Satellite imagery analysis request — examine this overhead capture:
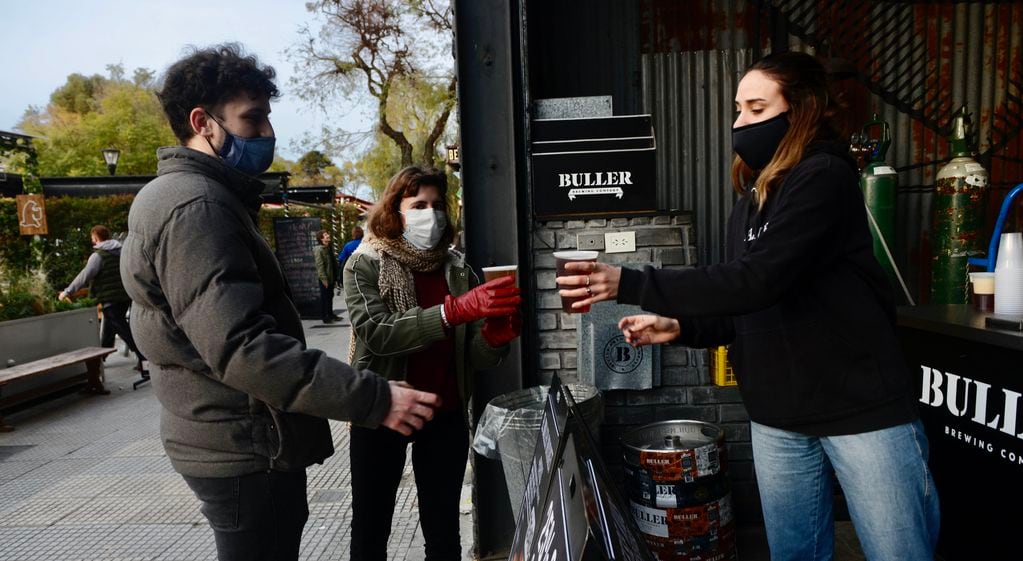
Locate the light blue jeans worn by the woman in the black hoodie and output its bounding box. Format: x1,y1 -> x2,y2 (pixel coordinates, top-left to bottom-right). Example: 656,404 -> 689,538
750,421 -> 940,561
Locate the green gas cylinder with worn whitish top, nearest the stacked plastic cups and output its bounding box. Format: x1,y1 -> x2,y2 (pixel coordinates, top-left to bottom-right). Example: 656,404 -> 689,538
931,105 -> 988,304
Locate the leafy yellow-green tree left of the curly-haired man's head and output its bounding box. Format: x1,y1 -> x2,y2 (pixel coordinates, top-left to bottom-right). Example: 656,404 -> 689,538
18,64 -> 177,176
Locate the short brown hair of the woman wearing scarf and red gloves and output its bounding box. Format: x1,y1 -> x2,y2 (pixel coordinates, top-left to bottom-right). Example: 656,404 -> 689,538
366,166 -> 454,248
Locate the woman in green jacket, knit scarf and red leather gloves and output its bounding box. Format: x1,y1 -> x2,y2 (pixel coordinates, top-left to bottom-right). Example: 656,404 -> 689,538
343,167 -> 522,561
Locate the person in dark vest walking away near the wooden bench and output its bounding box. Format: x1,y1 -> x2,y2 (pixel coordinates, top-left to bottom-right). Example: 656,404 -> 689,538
57,224 -> 149,379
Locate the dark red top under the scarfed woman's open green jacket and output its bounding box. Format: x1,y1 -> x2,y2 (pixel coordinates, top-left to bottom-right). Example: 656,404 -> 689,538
406,267 -> 461,411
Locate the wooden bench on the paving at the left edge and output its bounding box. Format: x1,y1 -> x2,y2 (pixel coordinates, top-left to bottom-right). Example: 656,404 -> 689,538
0,347 -> 117,432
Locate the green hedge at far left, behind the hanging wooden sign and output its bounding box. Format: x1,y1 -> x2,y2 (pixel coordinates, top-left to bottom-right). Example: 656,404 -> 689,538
0,196 -> 134,292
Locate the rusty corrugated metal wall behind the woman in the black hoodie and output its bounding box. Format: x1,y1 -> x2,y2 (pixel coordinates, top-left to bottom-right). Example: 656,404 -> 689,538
640,0 -> 1023,295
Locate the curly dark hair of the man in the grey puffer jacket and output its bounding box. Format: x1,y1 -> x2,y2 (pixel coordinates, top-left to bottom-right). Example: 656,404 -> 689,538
157,43 -> 280,144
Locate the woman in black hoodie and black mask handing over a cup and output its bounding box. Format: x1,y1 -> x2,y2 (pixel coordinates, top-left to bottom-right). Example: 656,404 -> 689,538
558,53 -> 939,561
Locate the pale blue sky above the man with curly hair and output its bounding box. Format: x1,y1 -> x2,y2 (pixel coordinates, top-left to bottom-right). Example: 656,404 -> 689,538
0,0 -> 371,160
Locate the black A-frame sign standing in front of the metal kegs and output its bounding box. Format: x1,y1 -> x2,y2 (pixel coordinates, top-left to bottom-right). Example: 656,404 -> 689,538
508,375 -> 654,561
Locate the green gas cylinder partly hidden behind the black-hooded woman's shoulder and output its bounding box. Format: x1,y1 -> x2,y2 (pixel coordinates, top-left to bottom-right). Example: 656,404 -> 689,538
858,114 -> 898,283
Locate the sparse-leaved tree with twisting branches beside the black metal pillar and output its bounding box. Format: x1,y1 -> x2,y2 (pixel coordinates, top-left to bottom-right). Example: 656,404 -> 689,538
291,0 -> 457,168
